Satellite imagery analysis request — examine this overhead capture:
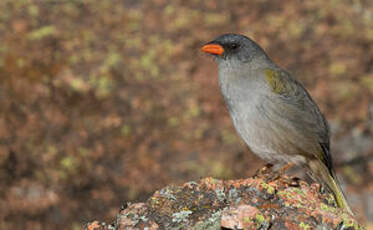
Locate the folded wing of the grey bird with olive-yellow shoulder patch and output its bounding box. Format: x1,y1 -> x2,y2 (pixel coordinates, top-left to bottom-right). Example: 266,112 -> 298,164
265,69 -> 332,164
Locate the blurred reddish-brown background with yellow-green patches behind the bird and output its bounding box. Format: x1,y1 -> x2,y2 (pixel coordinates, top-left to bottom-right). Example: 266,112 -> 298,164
0,0 -> 373,230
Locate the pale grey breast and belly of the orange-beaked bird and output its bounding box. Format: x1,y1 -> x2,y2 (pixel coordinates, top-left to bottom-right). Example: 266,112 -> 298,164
217,71 -> 312,164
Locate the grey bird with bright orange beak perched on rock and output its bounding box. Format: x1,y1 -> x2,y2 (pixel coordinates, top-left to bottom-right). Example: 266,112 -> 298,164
201,33 -> 354,215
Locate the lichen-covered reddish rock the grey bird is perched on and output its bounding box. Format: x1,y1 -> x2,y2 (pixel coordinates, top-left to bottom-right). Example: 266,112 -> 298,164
86,169 -> 364,230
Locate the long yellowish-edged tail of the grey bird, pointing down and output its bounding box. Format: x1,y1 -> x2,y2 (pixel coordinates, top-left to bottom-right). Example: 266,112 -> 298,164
310,160 -> 354,215
